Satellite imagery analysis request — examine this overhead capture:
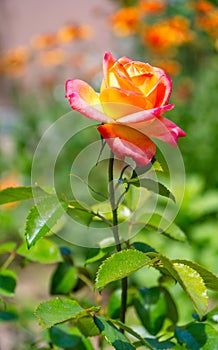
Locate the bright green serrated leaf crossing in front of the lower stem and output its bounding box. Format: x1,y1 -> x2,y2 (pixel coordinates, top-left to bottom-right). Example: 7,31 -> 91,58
95,249 -> 150,290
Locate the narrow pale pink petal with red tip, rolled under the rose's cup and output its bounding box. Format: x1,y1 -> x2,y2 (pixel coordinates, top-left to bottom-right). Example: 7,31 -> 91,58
118,104 -> 174,123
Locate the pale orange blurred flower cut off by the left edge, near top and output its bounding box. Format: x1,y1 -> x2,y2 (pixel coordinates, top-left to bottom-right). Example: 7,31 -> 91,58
0,46 -> 30,77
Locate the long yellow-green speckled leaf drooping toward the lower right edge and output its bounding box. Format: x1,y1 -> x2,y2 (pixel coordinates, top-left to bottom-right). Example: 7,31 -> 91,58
160,255 -> 208,318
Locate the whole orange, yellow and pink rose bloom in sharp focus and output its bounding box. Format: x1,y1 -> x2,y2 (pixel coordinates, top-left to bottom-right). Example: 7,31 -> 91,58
66,53 -> 185,166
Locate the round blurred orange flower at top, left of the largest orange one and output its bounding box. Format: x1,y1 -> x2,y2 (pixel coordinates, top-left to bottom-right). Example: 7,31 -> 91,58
111,7 -> 140,36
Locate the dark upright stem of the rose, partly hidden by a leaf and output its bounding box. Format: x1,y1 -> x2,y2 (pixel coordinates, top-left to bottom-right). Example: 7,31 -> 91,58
108,152 -> 128,333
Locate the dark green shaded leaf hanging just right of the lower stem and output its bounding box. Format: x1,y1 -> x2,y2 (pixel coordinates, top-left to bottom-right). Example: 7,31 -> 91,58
134,287 -> 167,335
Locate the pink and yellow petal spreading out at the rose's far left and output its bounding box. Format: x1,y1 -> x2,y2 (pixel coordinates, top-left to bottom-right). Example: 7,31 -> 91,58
66,79 -> 112,123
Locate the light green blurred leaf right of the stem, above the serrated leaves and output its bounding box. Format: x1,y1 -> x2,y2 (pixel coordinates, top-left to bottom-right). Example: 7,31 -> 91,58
140,213 -> 187,242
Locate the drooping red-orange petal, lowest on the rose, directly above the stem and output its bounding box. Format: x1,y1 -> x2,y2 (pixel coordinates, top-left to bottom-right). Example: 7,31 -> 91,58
98,123 -> 156,166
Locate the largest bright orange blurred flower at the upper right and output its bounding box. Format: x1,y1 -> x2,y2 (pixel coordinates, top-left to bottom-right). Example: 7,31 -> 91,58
143,16 -> 194,51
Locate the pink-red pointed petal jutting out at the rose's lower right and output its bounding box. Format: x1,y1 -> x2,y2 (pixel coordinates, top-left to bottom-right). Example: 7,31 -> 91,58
134,117 -> 186,146
